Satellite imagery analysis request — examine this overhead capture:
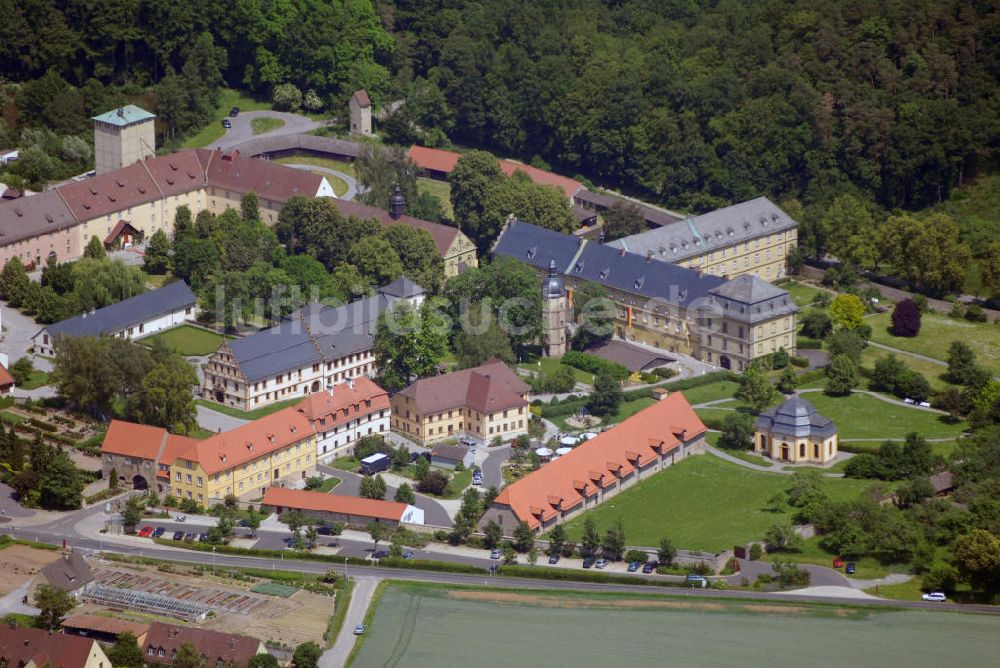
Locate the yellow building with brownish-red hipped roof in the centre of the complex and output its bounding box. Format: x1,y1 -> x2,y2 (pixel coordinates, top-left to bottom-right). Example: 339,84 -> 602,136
390,360 -> 531,443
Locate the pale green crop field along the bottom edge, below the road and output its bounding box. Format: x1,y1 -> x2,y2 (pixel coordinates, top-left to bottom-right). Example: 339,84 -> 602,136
348,583 -> 1000,668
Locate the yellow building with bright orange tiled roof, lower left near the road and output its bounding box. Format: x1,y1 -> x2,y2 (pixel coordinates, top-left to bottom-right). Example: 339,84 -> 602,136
170,407 -> 316,505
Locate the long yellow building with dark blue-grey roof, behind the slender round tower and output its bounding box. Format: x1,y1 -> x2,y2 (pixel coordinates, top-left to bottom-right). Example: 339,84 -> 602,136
493,221 -> 797,371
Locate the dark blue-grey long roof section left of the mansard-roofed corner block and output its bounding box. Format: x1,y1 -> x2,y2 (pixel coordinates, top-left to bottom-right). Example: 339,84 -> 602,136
493,220 -> 725,307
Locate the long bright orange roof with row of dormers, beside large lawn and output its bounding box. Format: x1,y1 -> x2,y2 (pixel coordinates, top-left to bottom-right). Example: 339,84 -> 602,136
493,392 -> 707,529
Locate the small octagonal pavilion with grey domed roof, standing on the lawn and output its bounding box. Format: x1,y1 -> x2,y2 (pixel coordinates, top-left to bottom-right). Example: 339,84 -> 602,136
754,395 -> 837,464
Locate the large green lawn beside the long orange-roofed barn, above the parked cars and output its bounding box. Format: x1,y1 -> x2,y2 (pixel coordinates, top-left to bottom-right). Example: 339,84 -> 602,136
552,455 -> 871,552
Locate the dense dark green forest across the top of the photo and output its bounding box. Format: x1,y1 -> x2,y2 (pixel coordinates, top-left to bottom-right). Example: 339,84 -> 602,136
0,0 -> 1000,218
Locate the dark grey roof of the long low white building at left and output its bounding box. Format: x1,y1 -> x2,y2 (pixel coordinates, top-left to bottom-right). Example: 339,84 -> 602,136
42,281 -> 197,336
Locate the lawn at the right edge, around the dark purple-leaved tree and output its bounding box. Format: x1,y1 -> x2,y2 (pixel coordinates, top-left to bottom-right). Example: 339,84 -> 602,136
867,312 -> 1000,380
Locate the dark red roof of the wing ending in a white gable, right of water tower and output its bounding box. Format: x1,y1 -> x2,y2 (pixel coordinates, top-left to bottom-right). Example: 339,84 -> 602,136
197,149 -> 323,202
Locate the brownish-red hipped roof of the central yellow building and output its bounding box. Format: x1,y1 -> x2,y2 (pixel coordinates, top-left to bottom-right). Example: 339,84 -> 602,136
399,359 -> 529,415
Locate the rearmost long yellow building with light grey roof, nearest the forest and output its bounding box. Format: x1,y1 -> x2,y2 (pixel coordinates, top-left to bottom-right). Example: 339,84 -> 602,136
608,197 -> 798,281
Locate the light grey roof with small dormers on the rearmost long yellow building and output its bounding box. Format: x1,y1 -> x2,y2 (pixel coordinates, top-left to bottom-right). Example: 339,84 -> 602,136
608,197 -> 798,262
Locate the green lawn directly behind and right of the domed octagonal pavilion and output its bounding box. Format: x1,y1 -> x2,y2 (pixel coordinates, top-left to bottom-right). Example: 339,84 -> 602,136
802,392 -> 969,441
